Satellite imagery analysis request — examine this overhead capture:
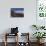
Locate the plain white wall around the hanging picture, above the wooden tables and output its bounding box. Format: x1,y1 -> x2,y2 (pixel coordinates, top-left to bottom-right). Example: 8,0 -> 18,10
0,0 -> 36,41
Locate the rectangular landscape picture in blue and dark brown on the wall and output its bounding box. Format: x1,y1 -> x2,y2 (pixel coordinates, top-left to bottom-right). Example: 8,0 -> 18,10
11,8 -> 24,17
